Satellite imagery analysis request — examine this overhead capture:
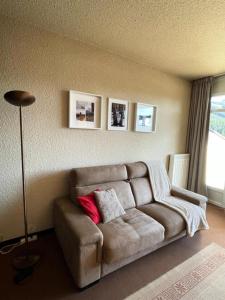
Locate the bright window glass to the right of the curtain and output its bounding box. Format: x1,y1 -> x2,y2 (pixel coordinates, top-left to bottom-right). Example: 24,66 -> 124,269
206,95 -> 225,190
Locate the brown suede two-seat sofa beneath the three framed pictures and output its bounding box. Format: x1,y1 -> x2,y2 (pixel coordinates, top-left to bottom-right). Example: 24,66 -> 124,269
54,162 -> 207,288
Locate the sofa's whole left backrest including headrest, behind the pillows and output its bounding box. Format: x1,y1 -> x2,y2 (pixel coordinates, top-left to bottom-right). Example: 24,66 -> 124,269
70,165 -> 135,209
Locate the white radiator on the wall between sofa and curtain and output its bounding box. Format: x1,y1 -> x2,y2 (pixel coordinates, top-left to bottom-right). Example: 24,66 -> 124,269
169,154 -> 190,189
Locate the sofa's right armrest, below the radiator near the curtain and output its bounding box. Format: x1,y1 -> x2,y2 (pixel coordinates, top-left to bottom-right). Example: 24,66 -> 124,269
171,186 -> 208,210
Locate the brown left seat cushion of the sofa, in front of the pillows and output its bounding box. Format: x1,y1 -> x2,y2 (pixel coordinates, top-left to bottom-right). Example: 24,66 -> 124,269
97,208 -> 165,263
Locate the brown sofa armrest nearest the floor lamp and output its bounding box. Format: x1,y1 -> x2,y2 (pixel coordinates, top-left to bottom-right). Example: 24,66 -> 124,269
54,198 -> 103,288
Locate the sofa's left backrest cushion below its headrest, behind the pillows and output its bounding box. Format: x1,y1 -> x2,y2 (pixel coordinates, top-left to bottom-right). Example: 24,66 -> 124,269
71,181 -> 135,209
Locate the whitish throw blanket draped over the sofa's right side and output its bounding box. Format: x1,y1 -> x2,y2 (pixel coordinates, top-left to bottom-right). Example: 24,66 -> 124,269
145,161 -> 209,237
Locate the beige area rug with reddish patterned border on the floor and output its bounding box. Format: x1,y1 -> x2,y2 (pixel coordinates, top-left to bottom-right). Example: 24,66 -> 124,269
126,243 -> 225,300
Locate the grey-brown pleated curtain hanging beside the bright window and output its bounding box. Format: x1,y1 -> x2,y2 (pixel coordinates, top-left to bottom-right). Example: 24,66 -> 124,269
186,77 -> 213,195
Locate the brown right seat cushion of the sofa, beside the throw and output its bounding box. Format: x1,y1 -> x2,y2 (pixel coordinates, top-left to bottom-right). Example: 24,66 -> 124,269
138,203 -> 186,239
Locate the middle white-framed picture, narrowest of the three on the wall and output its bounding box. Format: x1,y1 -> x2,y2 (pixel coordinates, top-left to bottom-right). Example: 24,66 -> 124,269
108,98 -> 128,131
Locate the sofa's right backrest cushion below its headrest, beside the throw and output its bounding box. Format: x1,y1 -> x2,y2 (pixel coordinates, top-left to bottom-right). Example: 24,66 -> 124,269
130,177 -> 153,206
